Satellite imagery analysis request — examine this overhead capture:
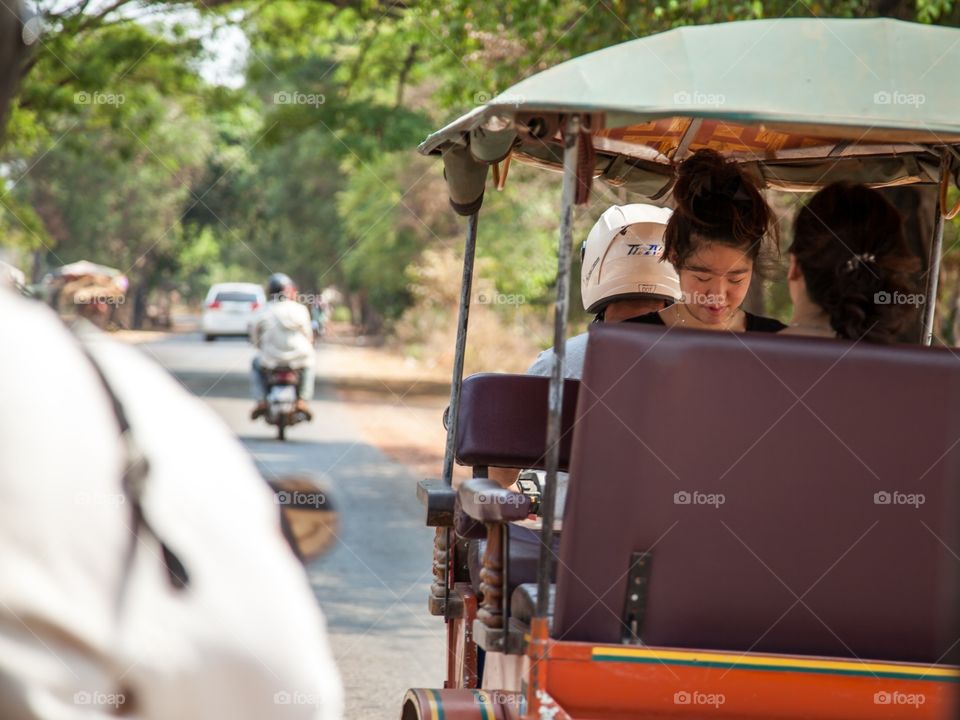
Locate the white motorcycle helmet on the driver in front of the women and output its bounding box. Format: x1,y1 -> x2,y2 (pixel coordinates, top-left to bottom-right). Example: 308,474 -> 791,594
580,203 -> 680,313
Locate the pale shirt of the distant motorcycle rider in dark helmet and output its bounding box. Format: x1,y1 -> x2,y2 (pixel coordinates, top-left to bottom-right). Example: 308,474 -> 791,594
250,300 -> 314,368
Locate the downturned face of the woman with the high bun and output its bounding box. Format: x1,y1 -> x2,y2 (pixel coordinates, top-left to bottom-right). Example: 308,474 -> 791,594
678,242 -> 753,325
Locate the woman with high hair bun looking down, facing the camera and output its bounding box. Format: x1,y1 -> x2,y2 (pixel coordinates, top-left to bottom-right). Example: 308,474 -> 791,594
627,149 -> 786,332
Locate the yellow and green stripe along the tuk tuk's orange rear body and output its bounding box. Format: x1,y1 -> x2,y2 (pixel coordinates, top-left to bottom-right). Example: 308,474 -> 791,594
591,647 -> 960,682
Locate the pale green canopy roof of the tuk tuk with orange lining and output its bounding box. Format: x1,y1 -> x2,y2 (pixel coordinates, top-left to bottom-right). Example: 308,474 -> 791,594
420,18 -> 960,202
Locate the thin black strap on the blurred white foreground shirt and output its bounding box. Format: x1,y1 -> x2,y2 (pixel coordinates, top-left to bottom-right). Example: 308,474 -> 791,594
74,332 -> 190,600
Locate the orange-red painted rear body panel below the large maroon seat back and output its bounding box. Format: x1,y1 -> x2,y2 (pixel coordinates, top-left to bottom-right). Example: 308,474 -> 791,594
524,620 -> 960,720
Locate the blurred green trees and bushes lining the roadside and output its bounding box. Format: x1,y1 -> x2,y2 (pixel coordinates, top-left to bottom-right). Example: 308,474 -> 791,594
0,0 -> 960,360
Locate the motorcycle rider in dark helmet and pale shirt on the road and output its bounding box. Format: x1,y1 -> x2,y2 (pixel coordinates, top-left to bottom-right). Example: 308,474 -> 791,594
250,273 -> 315,420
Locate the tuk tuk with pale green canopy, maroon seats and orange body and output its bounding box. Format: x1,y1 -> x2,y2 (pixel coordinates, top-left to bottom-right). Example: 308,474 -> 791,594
401,19 -> 960,720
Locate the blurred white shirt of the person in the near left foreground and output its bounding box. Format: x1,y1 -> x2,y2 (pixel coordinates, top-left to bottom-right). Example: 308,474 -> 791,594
0,289 -> 342,720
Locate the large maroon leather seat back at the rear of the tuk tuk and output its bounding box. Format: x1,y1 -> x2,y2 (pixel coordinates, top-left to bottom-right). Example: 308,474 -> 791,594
552,325 -> 960,662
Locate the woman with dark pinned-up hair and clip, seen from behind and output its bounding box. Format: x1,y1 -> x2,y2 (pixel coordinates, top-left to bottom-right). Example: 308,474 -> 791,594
783,183 -> 922,343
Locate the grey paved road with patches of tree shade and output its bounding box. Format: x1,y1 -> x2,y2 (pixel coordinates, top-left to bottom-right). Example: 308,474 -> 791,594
139,334 -> 444,720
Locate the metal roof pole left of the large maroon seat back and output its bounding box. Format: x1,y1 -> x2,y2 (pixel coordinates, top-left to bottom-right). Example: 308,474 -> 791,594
537,115 -> 580,618
